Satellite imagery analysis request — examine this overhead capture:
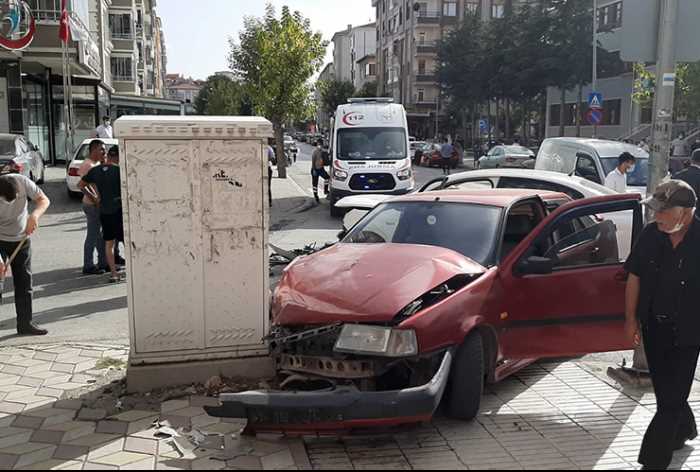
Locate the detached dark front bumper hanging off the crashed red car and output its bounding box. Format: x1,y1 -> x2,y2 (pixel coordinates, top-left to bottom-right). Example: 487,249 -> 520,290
204,351 -> 453,431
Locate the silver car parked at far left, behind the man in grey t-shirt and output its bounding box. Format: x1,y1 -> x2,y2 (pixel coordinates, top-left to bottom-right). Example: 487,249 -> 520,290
0,134 -> 46,184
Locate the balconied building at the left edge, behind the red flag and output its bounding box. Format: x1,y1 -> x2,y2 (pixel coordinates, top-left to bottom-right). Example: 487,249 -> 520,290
0,0 -> 174,162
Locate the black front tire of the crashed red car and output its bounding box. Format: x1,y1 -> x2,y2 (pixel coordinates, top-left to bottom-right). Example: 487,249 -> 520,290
446,332 -> 485,421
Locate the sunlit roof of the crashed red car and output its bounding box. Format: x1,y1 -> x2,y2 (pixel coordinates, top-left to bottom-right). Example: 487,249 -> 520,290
390,189 -> 571,208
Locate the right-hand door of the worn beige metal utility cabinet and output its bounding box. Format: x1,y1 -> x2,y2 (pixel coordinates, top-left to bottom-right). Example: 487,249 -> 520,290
195,140 -> 269,348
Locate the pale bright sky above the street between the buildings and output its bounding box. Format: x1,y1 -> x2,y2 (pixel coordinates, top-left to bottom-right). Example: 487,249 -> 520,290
156,0 -> 375,79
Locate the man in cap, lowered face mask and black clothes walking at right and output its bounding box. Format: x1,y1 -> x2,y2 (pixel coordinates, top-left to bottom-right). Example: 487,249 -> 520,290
625,180 -> 700,470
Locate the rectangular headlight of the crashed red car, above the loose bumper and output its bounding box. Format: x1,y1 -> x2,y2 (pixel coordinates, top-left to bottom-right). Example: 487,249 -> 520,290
334,325 -> 418,357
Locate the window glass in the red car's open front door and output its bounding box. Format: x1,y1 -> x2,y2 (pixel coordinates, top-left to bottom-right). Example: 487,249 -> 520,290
539,214 -> 620,270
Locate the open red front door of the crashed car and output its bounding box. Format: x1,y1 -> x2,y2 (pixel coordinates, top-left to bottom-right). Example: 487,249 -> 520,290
489,195 -> 642,359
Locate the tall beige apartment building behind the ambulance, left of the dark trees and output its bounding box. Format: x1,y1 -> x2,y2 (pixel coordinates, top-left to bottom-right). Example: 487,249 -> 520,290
372,0 -> 532,138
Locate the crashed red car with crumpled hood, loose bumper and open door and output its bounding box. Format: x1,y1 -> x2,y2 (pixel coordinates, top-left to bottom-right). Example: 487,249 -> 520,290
207,190 -> 642,433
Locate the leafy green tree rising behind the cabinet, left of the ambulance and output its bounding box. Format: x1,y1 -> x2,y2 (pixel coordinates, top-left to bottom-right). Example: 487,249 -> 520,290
229,4 -> 327,178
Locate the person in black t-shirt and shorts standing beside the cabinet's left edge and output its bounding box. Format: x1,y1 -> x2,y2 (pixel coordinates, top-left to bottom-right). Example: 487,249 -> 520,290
80,146 -> 124,283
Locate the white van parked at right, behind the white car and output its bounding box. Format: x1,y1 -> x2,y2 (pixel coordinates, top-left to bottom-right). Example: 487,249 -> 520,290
535,138 -> 649,195
